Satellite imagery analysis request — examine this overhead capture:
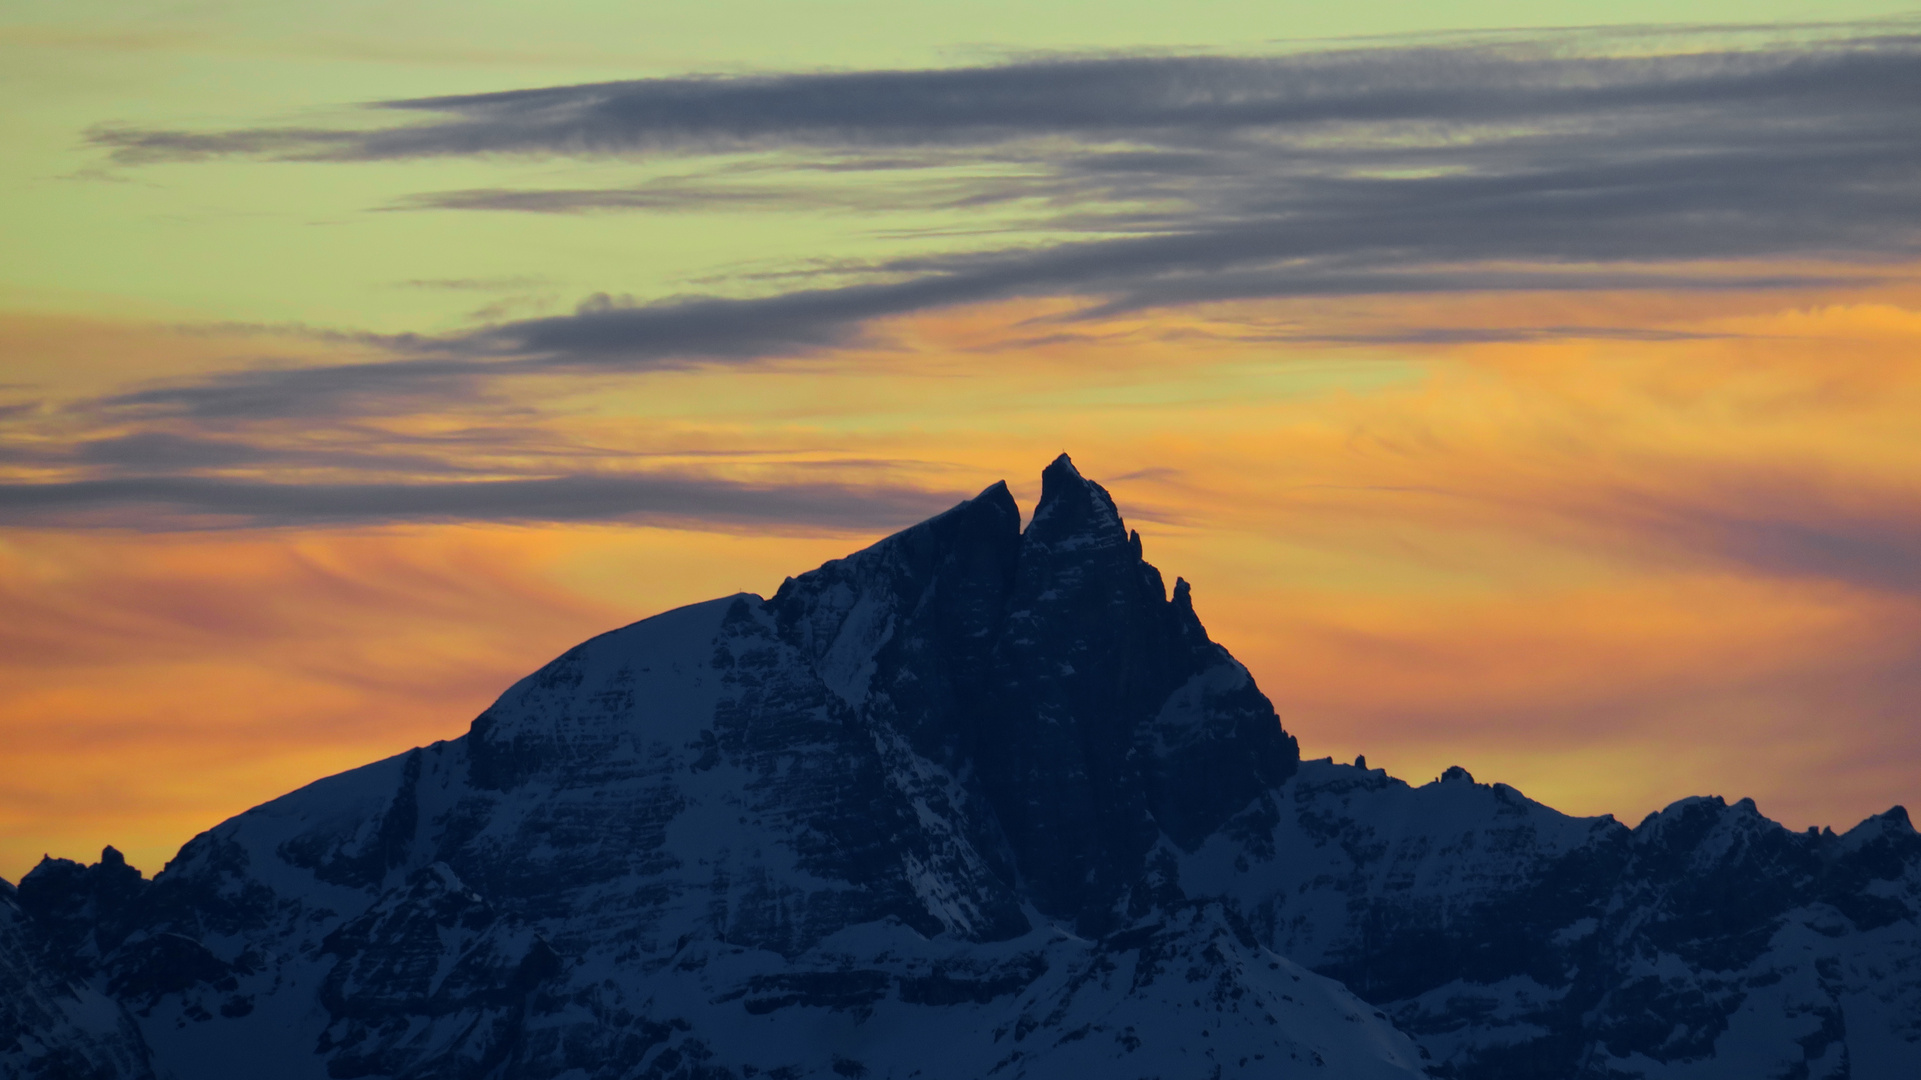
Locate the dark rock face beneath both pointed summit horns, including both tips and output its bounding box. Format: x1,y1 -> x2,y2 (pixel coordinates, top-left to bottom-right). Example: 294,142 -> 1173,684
768,455 -> 1301,938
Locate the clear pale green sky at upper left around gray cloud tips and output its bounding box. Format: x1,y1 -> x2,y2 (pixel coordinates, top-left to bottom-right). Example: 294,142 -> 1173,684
0,0 -> 1913,331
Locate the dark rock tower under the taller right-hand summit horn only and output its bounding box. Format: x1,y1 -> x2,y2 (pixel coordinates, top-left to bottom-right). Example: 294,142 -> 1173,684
974,455 -> 1301,932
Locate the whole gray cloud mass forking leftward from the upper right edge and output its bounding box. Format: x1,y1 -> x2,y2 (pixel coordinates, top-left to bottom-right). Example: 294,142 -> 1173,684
52,21 -> 1921,417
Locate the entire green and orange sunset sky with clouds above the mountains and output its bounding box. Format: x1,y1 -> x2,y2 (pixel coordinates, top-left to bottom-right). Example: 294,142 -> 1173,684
0,0 -> 1921,880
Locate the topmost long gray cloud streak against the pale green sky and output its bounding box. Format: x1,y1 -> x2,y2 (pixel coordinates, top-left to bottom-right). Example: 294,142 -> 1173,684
92,31 -> 1915,163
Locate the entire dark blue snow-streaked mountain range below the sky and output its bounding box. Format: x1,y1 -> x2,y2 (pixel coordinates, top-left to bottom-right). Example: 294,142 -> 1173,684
0,455 -> 1921,1080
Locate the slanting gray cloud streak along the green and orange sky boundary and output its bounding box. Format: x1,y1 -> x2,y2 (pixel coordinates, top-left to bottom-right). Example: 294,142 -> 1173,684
74,259 -> 1838,421
